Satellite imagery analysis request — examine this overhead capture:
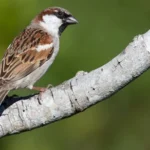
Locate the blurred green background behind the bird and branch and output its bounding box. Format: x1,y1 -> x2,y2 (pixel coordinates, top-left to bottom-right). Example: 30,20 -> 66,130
0,0 -> 150,150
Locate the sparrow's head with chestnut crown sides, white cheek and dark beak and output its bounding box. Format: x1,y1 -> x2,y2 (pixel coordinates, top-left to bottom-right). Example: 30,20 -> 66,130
32,7 -> 78,35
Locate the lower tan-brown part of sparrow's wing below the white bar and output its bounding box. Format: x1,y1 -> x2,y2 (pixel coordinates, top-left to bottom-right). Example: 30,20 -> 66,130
3,48 -> 53,81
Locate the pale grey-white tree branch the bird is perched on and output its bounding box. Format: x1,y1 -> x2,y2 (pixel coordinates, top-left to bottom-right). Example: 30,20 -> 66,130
0,31 -> 150,137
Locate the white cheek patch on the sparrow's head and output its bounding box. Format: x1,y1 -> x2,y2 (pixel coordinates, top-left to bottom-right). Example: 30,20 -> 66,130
40,15 -> 62,35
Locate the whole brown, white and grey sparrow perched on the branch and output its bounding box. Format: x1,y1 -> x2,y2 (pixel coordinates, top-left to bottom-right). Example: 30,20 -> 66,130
0,7 -> 78,104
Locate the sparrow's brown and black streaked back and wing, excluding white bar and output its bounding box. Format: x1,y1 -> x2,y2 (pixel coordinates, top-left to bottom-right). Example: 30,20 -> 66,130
0,29 -> 53,81
